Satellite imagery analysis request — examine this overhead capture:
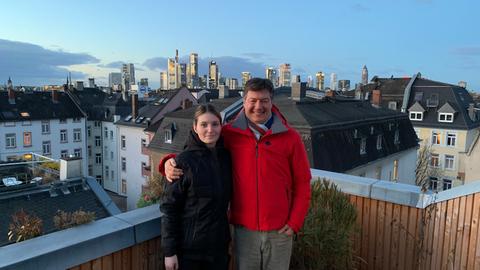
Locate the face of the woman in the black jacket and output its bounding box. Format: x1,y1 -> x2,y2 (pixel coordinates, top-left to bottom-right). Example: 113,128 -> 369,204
193,112 -> 222,147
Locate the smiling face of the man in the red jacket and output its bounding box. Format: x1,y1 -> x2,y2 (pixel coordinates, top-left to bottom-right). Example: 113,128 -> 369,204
243,89 -> 272,124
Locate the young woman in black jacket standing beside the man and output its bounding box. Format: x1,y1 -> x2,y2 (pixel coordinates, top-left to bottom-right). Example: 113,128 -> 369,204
160,105 -> 232,270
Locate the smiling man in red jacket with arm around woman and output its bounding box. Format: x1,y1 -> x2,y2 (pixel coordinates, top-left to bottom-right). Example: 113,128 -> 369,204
160,78 -> 311,270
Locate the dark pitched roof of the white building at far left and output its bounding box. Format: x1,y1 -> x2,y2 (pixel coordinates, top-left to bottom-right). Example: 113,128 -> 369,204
0,91 -> 85,122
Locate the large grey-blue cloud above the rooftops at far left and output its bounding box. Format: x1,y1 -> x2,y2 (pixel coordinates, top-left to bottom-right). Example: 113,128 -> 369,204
0,39 -> 99,85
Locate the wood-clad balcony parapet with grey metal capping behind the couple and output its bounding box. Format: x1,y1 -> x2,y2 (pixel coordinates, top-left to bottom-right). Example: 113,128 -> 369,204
0,170 -> 480,270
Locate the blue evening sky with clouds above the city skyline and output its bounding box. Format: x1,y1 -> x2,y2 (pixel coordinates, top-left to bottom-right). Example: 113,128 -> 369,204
0,0 -> 480,91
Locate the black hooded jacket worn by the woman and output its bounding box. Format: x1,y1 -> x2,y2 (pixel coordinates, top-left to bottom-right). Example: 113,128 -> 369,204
160,131 -> 232,260
